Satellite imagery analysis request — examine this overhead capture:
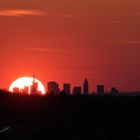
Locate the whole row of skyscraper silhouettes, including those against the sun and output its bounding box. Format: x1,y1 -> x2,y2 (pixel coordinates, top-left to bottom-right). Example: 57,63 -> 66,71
13,76 -> 118,96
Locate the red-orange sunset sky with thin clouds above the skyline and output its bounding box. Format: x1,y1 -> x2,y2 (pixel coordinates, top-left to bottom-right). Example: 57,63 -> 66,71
0,0 -> 140,91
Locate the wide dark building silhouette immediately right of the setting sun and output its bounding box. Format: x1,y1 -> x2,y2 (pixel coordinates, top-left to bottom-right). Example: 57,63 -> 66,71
47,81 -> 60,94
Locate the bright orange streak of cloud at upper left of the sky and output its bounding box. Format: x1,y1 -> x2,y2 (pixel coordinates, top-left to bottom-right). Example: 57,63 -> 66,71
0,9 -> 44,17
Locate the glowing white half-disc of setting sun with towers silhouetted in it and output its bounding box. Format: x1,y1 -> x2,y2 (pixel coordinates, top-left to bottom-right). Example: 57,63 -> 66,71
9,77 -> 45,94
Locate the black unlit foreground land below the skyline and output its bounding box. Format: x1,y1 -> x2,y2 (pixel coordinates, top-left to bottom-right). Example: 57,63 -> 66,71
0,95 -> 140,140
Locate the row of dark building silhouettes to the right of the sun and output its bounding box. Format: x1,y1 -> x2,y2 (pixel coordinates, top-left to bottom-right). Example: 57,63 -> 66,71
47,78 -> 118,96
